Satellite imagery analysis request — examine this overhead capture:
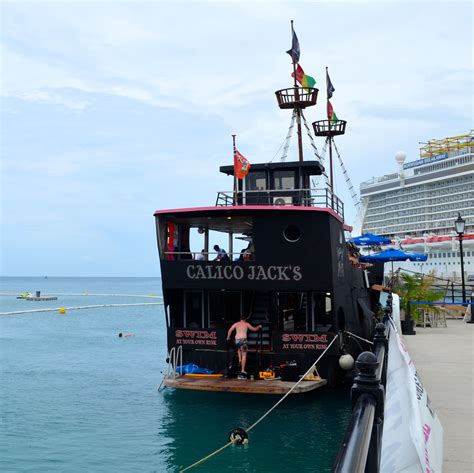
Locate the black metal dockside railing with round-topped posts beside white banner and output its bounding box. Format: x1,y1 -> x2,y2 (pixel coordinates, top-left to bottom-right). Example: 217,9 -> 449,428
332,294 -> 392,473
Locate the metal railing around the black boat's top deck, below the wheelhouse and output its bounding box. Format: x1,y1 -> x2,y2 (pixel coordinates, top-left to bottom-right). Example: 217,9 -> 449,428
216,187 -> 344,217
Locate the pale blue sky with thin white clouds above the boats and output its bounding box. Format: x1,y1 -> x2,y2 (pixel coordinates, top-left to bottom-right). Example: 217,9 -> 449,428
0,0 -> 473,276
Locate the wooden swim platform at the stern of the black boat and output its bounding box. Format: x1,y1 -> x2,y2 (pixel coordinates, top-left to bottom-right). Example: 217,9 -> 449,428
165,376 -> 326,394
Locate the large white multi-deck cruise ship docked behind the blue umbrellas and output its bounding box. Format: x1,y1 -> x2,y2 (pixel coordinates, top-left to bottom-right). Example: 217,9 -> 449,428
360,130 -> 474,281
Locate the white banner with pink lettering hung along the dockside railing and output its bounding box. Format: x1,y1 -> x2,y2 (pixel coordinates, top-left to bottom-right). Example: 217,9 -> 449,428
380,325 -> 443,473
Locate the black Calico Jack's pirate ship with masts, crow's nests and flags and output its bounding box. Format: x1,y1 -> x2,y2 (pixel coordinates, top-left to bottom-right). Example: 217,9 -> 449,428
155,24 -> 380,393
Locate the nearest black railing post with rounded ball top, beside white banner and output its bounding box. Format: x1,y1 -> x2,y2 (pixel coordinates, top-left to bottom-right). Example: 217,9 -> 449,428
351,351 -> 385,473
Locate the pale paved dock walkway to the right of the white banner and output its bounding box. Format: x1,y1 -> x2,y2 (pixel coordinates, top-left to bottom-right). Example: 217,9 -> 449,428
403,319 -> 474,473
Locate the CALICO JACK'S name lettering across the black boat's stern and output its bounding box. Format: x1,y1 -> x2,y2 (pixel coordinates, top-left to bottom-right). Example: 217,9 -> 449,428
186,264 -> 303,281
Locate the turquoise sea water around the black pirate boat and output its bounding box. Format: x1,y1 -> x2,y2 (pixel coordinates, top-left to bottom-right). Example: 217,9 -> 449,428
0,278 -> 350,473
